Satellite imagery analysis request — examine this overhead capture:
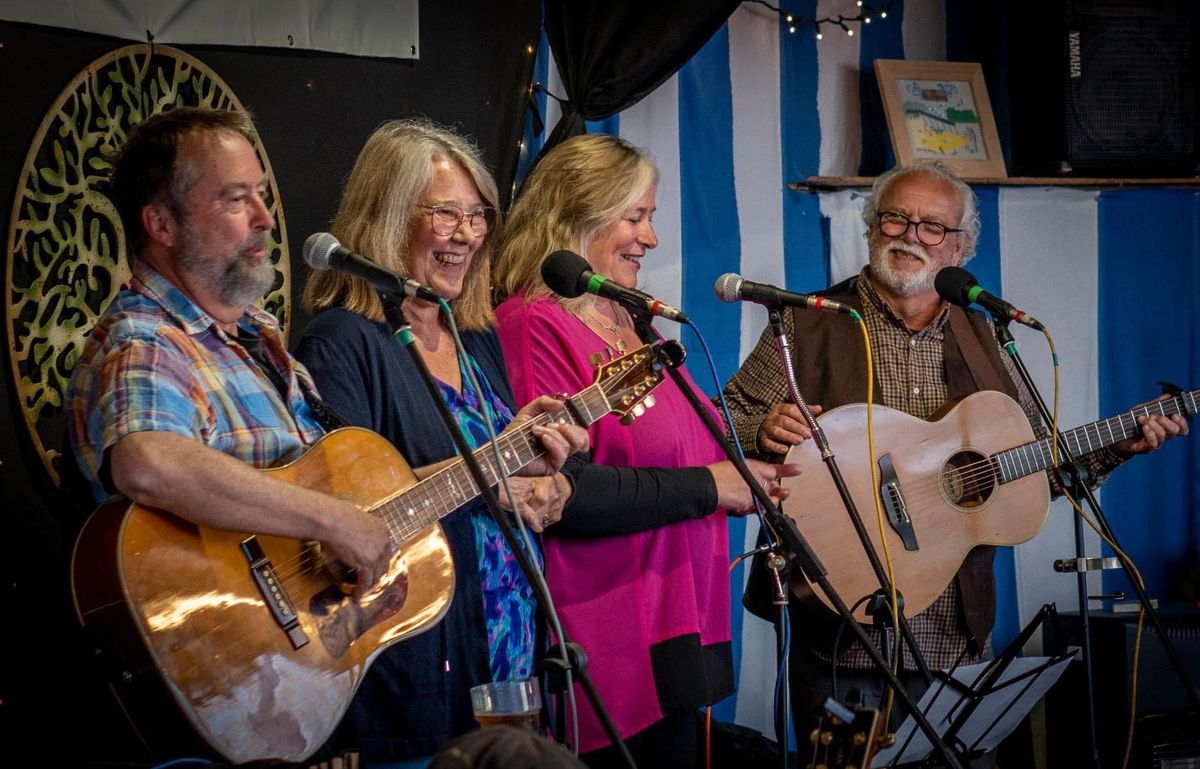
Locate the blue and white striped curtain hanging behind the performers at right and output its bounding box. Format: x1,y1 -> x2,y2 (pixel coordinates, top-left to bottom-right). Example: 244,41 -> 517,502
516,0 -> 1200,733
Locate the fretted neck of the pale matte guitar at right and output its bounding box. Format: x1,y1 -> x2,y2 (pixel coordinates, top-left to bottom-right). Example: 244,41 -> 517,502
994,390 -> 1200,483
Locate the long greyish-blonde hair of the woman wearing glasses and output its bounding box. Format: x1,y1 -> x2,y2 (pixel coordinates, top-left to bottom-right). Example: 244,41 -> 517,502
304,119 -> 503,330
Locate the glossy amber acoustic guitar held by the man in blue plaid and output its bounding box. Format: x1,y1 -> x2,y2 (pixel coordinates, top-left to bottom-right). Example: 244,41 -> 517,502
71,342 -> 682,763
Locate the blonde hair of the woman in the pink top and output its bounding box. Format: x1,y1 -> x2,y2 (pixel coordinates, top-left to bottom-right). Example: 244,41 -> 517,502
493,133 -> 659,310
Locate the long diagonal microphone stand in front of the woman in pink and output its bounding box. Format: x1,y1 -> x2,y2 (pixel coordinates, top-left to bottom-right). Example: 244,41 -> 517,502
635,316 -> 962,769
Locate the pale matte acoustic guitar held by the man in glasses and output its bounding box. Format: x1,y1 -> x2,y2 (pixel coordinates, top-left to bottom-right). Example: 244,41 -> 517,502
784,390 -> 1200,621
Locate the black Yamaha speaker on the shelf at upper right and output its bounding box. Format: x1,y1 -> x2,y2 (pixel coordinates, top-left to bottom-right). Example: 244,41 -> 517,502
1009,0 -> 1200,178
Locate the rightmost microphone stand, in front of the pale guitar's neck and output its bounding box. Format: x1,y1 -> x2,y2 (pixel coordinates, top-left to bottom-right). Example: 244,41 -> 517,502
990,312 -> 1200,767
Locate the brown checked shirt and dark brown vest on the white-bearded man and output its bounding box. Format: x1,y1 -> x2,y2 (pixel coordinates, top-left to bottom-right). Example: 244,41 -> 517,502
725,269 -> 1118,668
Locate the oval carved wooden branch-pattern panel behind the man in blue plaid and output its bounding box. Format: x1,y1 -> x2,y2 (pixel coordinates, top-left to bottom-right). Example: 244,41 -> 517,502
5,44 -> 290,483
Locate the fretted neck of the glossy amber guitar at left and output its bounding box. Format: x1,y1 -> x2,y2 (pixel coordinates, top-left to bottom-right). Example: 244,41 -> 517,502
373,384 -> 612,542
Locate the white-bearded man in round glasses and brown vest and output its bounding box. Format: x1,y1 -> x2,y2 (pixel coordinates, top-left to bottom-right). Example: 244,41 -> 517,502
725,162 -> 1187,765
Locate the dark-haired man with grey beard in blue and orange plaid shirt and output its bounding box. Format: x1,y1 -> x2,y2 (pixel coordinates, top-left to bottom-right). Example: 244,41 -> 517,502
67,108 -> 391,590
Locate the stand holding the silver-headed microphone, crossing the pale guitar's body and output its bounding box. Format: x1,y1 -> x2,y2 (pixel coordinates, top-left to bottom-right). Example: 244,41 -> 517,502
767,305 -> 934,684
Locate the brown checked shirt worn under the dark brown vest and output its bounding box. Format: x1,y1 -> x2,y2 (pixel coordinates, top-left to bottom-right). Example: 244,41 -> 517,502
725,268 -> 1120,669
